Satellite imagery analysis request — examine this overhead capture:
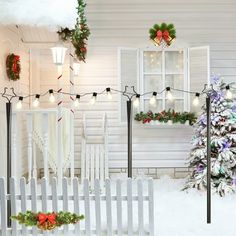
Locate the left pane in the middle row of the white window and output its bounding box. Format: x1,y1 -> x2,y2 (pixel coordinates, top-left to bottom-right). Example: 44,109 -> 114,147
144,75 -> 163,95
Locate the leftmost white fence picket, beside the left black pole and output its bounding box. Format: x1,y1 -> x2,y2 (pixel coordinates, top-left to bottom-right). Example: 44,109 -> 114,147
0,178 -> 7,236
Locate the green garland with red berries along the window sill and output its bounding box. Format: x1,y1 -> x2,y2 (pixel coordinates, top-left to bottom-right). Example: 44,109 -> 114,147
135,109 -> 197,125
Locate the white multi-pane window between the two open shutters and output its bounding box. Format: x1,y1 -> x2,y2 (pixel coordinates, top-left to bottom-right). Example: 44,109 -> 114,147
140,50 -> 188,112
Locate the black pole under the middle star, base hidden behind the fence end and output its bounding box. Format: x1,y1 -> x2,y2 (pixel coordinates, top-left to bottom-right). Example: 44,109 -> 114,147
127,99 -> 132,178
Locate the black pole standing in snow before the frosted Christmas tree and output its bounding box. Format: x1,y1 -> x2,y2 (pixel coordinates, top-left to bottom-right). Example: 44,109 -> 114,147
206,96 -> 211,224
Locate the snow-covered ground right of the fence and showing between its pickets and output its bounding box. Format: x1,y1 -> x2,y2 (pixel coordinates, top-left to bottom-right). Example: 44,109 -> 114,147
9,176 -> 236,236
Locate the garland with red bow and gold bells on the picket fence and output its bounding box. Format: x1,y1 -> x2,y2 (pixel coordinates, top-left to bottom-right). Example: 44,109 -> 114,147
11,211 -> 84,230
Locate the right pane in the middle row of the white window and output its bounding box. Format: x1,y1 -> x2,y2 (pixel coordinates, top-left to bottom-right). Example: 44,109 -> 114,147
165,75 -> 184,98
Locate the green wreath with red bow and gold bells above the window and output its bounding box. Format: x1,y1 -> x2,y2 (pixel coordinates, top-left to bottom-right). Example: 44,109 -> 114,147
149,23 -> 176,46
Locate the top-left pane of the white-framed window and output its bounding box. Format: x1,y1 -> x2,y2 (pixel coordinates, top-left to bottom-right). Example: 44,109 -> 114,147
143,51 -> 162,73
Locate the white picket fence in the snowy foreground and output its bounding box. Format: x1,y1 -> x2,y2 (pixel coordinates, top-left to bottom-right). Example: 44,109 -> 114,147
0,178 -> 154,236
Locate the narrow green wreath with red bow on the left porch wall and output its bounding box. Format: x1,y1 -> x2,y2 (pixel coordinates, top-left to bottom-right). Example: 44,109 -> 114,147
6,53 -> 21,80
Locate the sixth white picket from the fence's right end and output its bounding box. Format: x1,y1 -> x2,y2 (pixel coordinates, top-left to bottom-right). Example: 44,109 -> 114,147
94,179 -> 101,235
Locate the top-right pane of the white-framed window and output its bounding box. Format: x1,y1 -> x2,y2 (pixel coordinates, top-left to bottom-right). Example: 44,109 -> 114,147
165,51 -> 184,74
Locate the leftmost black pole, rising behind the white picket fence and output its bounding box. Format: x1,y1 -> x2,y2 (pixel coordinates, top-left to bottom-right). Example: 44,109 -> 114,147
6,101 -> 12,227
